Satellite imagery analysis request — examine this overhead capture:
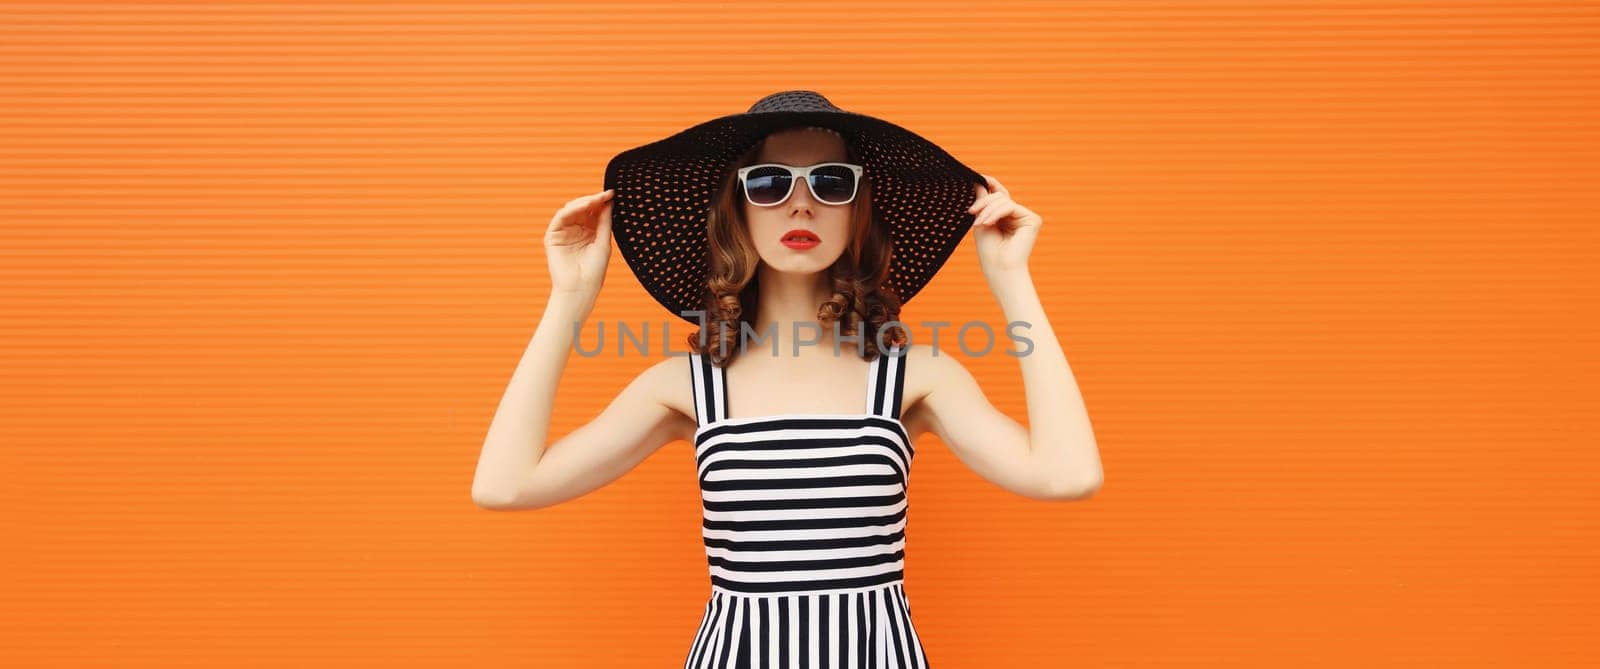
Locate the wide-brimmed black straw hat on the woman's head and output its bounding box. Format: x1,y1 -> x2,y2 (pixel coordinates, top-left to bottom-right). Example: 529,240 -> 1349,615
605,91 -> 987,325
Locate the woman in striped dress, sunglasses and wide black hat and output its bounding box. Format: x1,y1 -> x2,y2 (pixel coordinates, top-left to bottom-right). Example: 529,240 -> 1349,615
472,91 -> 1101,667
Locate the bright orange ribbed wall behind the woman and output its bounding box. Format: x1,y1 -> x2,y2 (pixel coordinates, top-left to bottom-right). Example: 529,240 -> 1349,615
0,0 -> 1600,669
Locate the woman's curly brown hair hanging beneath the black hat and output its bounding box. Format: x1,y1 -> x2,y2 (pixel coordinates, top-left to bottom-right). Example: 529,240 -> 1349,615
688,131 -> 907,367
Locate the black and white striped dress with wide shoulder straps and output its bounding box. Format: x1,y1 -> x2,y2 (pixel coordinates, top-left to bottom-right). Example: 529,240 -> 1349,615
683,347 -> 928,669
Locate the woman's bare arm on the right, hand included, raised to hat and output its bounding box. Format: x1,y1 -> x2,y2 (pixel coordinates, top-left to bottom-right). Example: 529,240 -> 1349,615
925,176 -> 1104,498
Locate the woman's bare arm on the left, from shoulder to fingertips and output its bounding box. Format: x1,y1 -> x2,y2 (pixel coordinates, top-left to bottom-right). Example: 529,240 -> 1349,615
472,190 -> 693,511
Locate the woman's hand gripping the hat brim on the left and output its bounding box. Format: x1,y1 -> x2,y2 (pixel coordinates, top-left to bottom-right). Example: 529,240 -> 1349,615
544,189 -> 614,302
